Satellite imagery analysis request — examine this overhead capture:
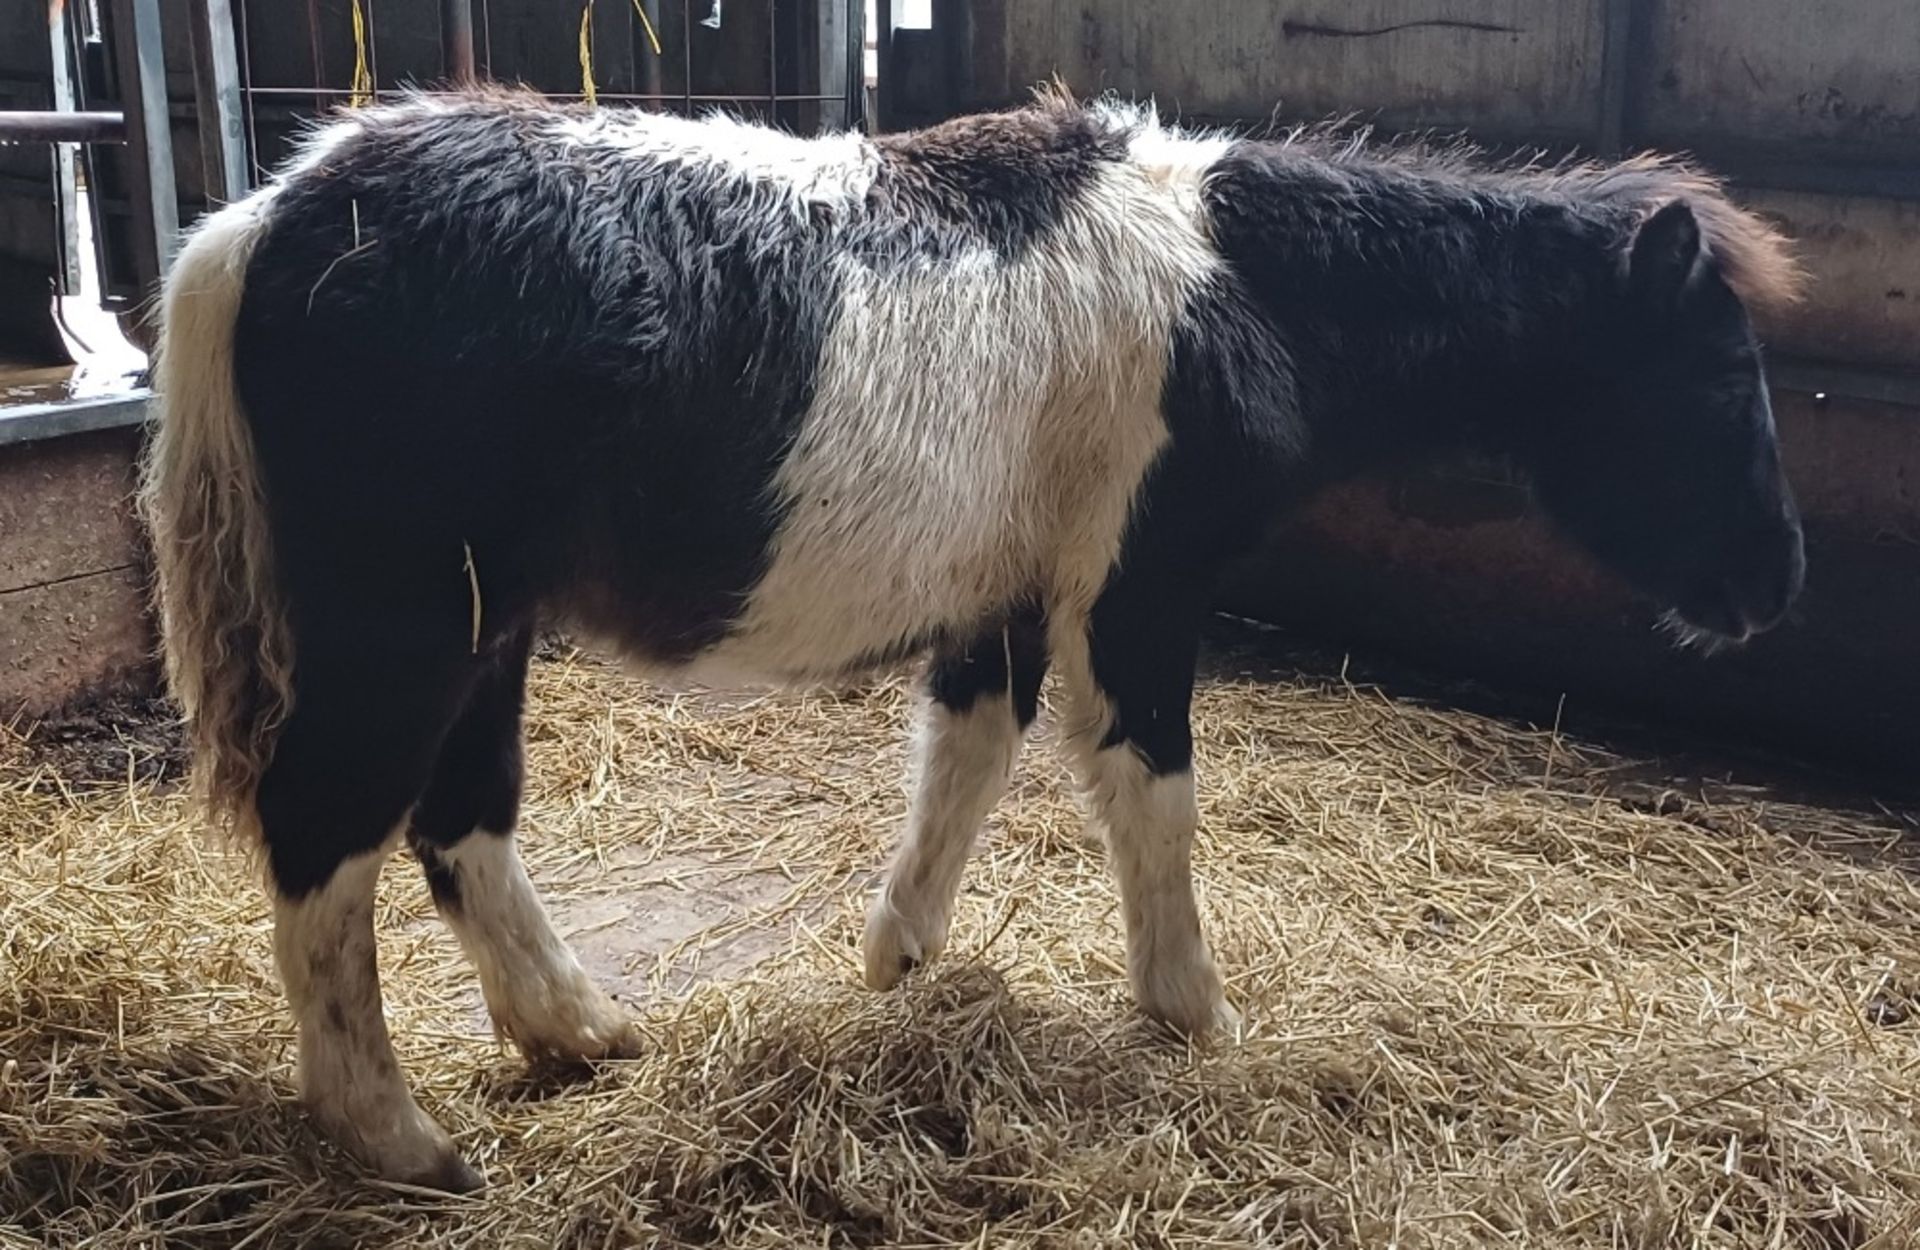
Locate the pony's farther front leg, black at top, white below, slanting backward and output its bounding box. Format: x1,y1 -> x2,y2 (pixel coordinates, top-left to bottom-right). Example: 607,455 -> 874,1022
864,614 -> 1046,989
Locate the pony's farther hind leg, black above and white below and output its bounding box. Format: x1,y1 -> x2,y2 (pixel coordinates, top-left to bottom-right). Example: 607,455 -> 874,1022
407,634 -> 639,1060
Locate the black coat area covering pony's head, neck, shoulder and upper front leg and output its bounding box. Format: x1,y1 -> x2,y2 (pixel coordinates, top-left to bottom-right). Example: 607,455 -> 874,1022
1089,129 -> 1803,791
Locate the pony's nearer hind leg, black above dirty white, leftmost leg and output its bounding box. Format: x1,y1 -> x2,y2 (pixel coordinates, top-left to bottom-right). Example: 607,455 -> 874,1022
255,636 -> 480,1190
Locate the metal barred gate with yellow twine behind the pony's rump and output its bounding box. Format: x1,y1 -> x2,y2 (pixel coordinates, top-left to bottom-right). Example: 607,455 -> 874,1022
0,0 -> 864,337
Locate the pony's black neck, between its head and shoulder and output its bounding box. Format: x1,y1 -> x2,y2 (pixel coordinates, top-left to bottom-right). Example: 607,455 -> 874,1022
1213,148 -> 1624,472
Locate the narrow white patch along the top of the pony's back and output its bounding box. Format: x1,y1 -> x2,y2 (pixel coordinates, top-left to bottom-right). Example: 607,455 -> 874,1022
547,109 -> 879,211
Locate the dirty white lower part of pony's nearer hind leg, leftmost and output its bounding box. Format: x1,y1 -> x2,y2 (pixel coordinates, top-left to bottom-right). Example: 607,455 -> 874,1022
273,843 -> 480,1192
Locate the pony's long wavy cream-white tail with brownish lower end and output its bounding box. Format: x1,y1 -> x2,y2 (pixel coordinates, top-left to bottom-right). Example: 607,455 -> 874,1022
140,192 -> 294,824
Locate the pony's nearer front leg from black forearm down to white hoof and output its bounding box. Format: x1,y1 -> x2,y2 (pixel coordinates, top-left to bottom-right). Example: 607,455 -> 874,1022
1060,591 -> 1240,1035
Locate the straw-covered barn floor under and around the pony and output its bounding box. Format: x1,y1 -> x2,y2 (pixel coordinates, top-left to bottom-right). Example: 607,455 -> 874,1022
0,629 -> 1920,1250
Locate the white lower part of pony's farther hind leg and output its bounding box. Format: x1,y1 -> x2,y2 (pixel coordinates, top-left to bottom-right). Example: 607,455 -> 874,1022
434,829 -> 639,1060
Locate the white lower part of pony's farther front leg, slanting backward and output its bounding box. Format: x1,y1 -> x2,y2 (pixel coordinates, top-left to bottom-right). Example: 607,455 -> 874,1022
864,693 -> 1020,989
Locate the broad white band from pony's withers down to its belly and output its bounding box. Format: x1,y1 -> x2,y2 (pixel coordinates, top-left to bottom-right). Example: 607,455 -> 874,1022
699,146 -> 1219,682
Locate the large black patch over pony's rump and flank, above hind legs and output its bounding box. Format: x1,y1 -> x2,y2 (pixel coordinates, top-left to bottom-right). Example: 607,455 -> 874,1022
236,102 -> 835,661
